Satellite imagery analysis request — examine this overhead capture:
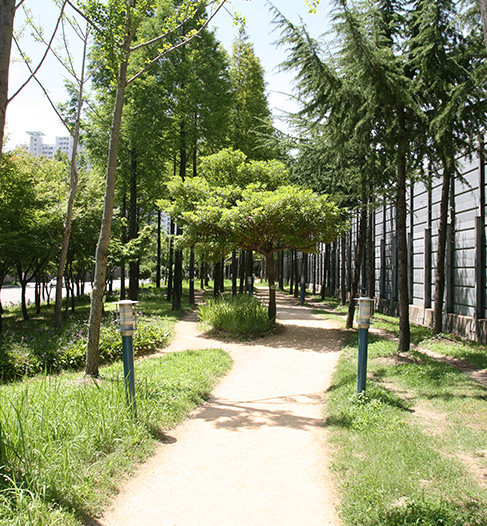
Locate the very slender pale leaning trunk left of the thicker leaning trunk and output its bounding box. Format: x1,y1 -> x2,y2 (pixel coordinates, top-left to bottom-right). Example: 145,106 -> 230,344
54,27 -> 89,329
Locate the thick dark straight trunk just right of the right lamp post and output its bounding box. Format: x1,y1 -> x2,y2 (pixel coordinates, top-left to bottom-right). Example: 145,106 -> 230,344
397,109 -> 411,352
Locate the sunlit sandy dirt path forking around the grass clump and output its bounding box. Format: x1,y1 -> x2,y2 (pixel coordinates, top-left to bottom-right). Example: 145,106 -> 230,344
99,294 -> 341,526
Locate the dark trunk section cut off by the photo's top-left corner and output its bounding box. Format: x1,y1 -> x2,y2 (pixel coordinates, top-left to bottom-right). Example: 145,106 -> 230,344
0,0 -> 16,170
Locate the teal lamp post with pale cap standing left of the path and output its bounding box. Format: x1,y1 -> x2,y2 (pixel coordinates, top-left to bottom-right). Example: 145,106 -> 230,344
117,300 -> 137,414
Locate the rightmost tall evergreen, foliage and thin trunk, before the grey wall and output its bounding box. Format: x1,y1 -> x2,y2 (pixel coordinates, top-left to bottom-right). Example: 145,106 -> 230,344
409,0 -> 486,334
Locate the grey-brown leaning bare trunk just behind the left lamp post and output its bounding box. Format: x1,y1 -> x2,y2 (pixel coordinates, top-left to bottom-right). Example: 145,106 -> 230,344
85,9 -> 132,377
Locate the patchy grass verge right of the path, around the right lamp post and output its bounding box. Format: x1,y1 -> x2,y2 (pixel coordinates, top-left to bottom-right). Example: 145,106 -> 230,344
325,310 -> 487,526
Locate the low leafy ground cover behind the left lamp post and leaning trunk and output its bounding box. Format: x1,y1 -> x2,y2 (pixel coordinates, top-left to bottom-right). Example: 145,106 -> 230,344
0,287 -> 189,381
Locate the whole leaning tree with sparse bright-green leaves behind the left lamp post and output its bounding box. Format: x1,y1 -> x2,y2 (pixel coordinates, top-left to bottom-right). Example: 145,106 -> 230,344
80,0 -> 229,376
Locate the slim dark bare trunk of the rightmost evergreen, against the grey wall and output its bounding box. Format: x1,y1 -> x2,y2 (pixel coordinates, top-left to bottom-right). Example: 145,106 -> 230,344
433,162 -> 451,334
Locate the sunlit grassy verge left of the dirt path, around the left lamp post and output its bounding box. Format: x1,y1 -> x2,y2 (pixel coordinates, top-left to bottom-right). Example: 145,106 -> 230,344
0,350 -> 231,526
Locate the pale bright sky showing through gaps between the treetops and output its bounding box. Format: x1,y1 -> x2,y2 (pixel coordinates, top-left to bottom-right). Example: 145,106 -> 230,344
6,0 -> 330,148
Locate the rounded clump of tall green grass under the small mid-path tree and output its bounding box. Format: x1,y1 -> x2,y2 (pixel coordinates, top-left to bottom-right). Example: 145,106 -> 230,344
198,294 -> 272,336
